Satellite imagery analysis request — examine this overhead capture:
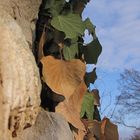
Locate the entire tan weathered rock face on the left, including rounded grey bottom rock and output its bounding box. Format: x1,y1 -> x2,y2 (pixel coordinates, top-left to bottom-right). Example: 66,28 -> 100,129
0,0 -> 73,140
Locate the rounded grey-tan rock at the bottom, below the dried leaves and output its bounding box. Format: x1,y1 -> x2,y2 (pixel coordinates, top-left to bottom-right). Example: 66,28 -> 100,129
14,110 -> 74,140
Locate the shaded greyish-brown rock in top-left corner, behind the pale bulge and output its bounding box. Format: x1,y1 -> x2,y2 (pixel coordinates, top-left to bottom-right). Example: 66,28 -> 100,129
0,0 -> 41,45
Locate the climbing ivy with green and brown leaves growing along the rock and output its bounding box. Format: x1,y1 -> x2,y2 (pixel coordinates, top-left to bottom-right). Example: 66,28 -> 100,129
33,0 -> 118,140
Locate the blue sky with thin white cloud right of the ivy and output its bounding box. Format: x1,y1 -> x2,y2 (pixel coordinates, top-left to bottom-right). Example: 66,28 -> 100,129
83,0 -> 140,139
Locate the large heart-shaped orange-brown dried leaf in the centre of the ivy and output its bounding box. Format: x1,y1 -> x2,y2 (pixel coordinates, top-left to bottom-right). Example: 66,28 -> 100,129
41,56 -> 86,100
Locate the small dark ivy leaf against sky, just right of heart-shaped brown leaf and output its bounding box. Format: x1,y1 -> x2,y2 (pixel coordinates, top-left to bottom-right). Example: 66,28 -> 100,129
85,68 -> 97,87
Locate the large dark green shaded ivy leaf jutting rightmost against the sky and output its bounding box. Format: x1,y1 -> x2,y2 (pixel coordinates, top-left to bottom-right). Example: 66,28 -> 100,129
83,38 -> 102,64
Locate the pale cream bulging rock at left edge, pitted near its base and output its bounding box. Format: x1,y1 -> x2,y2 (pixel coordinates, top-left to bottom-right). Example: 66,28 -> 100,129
0,9 -> 41,140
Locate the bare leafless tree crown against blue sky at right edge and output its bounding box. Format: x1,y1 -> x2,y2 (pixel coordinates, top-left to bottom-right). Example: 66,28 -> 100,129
116,69 -> 140,117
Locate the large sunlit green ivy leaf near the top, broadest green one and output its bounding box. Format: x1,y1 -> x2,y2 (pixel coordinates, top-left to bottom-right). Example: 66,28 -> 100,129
51,14 -> 85,38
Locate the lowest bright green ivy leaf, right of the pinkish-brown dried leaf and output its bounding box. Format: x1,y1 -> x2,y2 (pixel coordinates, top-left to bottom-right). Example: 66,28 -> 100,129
80,92 -> 94,120
